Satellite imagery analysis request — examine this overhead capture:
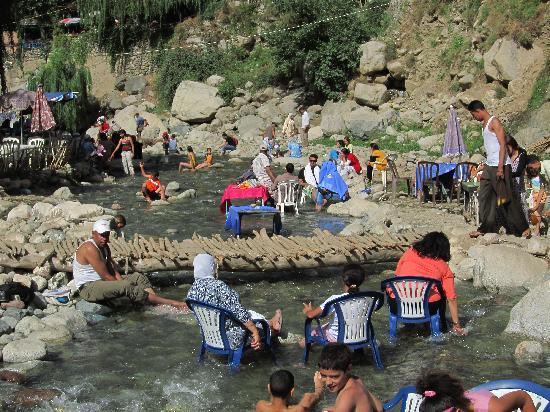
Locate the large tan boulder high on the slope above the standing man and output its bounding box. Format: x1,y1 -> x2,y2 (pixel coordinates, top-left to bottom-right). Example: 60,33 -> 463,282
483,39 -> 544,83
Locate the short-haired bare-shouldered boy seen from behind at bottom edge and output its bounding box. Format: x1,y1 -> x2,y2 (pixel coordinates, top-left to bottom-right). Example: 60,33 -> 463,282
256,369 -> 323,412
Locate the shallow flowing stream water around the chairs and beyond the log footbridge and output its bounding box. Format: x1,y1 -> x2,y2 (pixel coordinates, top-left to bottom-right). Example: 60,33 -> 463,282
0,156 -> 550,411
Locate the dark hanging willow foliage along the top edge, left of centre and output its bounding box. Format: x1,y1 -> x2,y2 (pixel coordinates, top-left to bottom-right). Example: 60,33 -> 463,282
77,0 -> 210,63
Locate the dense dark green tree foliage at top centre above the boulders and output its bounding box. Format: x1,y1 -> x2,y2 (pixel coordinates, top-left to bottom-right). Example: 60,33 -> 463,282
266,0 -> 386,99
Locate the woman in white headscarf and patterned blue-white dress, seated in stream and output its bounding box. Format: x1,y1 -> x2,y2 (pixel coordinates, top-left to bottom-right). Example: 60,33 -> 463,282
187,253 -> 283,350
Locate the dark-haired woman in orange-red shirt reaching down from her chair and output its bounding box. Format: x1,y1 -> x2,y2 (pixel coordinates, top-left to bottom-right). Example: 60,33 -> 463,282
389,232 -> 466,335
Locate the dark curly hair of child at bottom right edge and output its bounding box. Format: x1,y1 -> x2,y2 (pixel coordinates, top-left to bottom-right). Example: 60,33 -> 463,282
416,370 -> 470,412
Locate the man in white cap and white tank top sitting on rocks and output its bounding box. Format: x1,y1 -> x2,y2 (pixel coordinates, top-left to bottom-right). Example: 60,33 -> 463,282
73,219 -> 187,310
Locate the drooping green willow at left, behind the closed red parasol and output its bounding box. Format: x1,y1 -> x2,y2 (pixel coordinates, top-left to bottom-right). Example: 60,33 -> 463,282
29,34 -> 92,132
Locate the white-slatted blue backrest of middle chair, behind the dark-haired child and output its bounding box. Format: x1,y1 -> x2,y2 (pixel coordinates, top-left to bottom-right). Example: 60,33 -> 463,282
320,291 -> 384,344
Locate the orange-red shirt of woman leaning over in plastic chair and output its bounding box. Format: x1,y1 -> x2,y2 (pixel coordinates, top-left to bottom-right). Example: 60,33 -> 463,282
395,247 -> 456,302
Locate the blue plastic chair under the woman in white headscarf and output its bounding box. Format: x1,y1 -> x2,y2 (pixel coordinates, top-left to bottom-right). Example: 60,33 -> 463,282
186,299 -> 274,370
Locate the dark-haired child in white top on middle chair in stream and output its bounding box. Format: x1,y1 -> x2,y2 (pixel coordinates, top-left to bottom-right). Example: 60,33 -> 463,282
300,264 -> 365,346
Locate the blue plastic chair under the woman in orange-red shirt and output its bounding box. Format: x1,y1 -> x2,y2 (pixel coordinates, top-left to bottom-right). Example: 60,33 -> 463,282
380,276 -> 446,342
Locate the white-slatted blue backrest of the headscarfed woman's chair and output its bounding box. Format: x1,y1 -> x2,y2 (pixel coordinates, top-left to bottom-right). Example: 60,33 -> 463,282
186,299 -> 241,350
